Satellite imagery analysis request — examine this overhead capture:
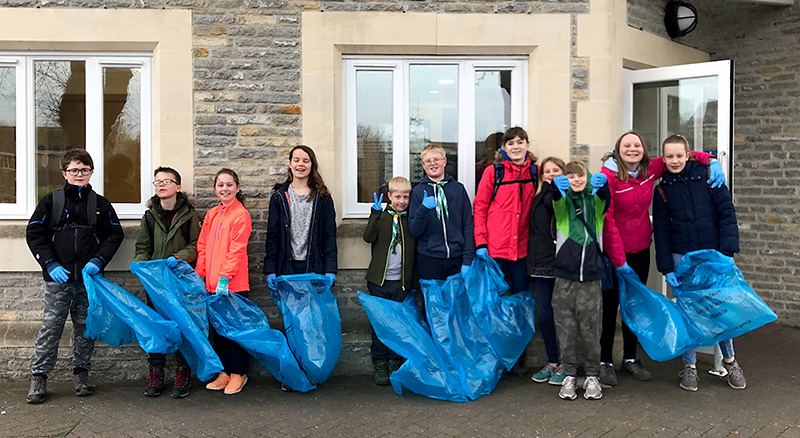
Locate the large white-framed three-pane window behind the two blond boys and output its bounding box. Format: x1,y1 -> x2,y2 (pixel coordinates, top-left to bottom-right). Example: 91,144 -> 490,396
343,56 -> 527,217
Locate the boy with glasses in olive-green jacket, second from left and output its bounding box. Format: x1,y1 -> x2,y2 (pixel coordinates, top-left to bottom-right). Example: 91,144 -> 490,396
133,167 -> 200,398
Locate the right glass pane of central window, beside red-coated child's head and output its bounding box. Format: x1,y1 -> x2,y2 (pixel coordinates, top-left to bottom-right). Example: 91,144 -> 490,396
475,71 -> 511,192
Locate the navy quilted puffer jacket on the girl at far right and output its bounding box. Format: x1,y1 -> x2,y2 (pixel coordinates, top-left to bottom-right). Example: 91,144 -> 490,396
653,161 -> 739,274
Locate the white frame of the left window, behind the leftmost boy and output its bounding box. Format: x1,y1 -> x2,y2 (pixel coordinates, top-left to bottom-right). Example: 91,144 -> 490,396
0,52 -> 154,219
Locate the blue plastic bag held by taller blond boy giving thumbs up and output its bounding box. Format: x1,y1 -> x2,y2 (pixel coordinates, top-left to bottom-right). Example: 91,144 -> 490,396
420,273 -> 503,400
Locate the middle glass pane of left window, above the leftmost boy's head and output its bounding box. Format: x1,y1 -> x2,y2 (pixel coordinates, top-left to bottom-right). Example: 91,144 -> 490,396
33,61 -> 86,199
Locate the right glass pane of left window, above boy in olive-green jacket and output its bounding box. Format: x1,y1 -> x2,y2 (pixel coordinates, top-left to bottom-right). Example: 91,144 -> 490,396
103,67 -> 141,203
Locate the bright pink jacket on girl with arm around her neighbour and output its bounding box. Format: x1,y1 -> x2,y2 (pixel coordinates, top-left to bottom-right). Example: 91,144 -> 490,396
601,151 -> 714,267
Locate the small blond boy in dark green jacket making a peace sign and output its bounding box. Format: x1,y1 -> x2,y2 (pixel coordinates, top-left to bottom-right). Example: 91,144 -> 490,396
364,176 -> 417,386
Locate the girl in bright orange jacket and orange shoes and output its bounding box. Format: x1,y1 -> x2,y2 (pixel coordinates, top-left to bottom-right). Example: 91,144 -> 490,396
195,169 -> 253,395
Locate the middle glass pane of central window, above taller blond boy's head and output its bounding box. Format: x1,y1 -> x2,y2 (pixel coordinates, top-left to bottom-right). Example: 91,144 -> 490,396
408,65 -> 458,184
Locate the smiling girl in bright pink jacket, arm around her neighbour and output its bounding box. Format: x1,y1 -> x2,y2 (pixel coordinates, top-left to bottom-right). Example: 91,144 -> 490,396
600,132 -> 725,386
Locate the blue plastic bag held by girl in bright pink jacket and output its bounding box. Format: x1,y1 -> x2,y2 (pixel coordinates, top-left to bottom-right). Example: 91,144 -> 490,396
617,271 -> 698,362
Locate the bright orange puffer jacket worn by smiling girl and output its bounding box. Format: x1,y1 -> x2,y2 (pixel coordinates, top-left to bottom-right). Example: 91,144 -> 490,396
195,200 -> 253,292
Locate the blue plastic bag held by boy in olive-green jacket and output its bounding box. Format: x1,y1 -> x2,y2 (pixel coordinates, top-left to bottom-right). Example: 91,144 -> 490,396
131,260 -> 222,381
